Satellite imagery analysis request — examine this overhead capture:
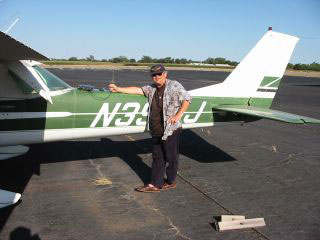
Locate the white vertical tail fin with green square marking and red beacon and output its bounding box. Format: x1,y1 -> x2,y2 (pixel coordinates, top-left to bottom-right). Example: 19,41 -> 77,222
190,30 -> 299,108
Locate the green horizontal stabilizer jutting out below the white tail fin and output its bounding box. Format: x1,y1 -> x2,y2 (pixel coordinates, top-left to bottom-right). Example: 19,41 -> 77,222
214,105 -> 320,124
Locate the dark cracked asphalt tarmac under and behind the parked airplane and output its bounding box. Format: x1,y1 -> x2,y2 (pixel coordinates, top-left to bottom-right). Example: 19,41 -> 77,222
0,69 -> 320,240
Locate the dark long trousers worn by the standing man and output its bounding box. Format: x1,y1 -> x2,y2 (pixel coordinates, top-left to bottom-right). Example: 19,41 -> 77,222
151,129 -> 181,187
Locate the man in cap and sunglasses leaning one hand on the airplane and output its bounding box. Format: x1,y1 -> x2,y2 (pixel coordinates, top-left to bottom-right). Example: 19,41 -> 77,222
109,64 -> 191,192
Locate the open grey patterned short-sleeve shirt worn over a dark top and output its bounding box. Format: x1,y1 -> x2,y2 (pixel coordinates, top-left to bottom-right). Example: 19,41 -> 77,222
141,79 -> 191,140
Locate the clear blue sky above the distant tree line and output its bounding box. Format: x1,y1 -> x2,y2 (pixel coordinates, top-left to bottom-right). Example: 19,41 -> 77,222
0,0 -> 320,64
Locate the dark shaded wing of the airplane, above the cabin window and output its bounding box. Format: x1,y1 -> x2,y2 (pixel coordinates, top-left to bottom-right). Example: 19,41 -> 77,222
0,31 -> 48,60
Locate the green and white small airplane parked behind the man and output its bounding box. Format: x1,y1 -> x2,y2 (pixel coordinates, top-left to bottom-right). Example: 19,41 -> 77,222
0,29 -> 320,208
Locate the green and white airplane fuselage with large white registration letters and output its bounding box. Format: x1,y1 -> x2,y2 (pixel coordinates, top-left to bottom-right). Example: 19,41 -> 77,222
0,88 -> 256,146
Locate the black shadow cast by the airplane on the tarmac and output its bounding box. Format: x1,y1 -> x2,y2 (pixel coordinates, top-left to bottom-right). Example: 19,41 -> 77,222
0,130 -> 236,232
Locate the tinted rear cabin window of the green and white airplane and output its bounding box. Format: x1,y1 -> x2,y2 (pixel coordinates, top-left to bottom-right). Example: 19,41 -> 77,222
33,66 -> 71,91
